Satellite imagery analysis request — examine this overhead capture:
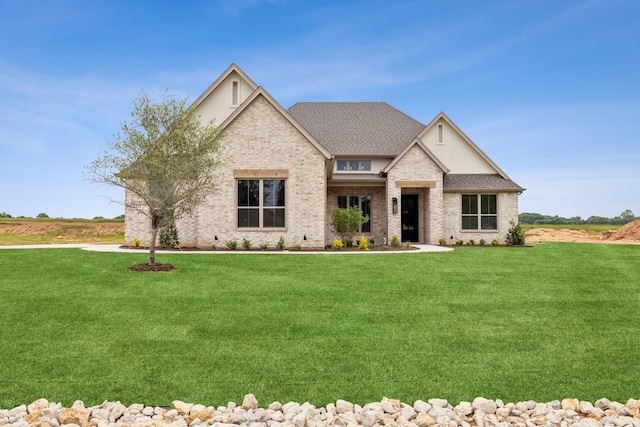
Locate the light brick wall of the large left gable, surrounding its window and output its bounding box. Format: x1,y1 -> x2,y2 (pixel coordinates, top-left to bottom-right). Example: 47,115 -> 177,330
125,92 -> 326,248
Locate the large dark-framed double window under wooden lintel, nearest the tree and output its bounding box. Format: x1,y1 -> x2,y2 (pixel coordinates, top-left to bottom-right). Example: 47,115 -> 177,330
238,179 -> 285,228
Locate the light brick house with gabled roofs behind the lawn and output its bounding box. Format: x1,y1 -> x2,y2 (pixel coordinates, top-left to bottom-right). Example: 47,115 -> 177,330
125,64 -> 524,248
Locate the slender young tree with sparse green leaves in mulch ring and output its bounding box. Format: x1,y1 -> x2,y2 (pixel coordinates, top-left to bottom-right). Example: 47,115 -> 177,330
87,91 -> 221,266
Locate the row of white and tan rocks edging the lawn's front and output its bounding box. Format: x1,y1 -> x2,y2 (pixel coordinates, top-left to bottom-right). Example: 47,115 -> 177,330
0,394 -> 640,427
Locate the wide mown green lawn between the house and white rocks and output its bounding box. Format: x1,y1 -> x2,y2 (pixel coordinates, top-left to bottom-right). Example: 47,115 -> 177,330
0,243 -> 640,408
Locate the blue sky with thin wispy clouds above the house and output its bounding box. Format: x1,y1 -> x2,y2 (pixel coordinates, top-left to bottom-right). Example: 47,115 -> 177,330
0,0 -> 640,218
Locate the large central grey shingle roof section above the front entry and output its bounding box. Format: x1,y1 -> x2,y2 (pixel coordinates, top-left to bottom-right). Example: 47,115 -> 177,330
287,102 -> 425,156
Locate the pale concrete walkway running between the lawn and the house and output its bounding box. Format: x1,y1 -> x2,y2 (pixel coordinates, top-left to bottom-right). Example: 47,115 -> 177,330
0,243 -> 453,255
